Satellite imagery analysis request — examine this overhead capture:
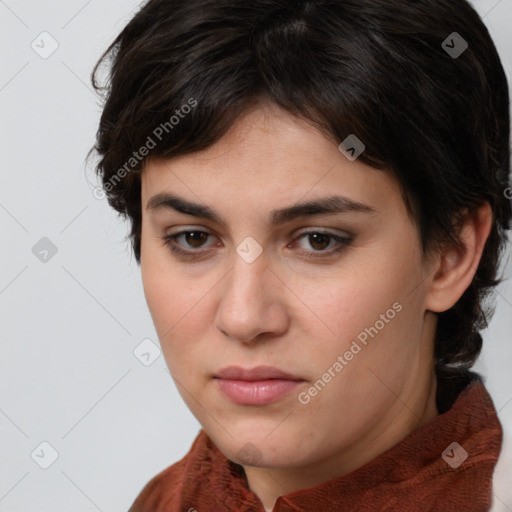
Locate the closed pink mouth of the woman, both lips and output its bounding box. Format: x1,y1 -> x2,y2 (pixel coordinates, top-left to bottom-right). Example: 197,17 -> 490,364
214,366 -> 305,405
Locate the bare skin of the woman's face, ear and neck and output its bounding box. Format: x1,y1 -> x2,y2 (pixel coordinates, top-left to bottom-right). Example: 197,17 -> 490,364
141,104 -> 491,511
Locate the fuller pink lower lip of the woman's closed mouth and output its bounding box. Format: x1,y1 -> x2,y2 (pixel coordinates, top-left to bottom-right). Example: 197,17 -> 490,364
215,379 -> 304,405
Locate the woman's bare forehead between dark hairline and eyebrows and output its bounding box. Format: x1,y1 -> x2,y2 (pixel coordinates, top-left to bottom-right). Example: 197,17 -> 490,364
142,105 -> 401,220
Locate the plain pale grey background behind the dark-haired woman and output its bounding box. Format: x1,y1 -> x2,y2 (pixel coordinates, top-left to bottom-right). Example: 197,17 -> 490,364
0,0 -> 512,512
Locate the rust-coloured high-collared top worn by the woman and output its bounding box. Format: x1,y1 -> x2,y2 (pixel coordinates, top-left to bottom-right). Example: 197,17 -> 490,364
128,371 -> 503,512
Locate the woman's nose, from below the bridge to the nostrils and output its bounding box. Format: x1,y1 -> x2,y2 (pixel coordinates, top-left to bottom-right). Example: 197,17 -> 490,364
216,253 -> 289,343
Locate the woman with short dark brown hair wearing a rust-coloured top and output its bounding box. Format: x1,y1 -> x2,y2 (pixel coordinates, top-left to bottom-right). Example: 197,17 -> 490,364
93,0 -> 511,512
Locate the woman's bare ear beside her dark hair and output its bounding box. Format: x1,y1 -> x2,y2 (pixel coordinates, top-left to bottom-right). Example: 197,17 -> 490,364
425,202 -> 493,313
